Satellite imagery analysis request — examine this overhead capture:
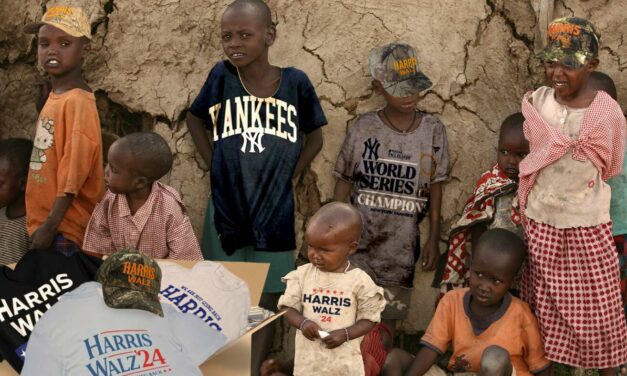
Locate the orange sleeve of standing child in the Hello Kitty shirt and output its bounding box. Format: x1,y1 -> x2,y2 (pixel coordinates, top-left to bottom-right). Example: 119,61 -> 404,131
57,94 -> 102,197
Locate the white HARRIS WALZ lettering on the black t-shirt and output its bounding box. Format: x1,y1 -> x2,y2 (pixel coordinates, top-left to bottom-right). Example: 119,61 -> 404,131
0,273 -> 74,336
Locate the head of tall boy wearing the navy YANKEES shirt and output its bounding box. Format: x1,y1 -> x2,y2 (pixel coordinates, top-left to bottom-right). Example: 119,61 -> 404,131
220,0 -> 276,68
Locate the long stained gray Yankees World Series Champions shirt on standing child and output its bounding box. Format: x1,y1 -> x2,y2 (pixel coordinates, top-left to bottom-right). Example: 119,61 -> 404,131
335,112 -> 449,287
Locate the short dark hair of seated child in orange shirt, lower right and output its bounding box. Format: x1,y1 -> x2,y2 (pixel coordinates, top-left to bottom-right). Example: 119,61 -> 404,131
472,228 -> 527,278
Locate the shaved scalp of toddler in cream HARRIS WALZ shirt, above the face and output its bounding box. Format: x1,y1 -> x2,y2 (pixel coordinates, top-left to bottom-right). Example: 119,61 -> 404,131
307,202 -> 362,242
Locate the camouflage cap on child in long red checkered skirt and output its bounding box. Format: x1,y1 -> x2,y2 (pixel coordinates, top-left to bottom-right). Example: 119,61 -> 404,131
538,17 -> 599,69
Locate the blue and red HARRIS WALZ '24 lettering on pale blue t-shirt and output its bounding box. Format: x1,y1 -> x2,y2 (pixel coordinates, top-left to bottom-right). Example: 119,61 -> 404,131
83,329 -> 172,376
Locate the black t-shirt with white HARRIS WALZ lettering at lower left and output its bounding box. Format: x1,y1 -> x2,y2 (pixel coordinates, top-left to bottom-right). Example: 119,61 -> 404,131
0,250 -> 101,371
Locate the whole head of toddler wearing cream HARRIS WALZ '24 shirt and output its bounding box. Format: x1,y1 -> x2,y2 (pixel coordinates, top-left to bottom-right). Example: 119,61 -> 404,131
305,202 -> 362,273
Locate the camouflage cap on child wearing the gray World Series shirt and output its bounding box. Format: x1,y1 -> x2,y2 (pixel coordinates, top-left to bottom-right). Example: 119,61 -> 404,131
370,43 -> 433,97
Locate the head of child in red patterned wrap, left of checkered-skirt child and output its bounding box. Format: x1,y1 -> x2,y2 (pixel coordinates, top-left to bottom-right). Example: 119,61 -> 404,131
496,112 -> 529,181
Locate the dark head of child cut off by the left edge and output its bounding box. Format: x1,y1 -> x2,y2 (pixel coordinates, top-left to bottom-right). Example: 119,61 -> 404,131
0,138 -> 33,208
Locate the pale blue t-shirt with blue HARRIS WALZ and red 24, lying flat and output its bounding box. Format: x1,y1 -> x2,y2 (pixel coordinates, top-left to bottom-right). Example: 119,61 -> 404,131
21,282 -> 226,376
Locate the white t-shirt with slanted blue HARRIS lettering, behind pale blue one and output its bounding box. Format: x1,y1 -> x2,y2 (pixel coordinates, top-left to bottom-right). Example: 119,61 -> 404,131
159,261 -> 250,341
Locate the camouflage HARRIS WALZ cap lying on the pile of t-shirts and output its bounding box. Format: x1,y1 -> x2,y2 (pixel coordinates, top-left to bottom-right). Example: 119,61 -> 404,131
96,249 -> 163,317
